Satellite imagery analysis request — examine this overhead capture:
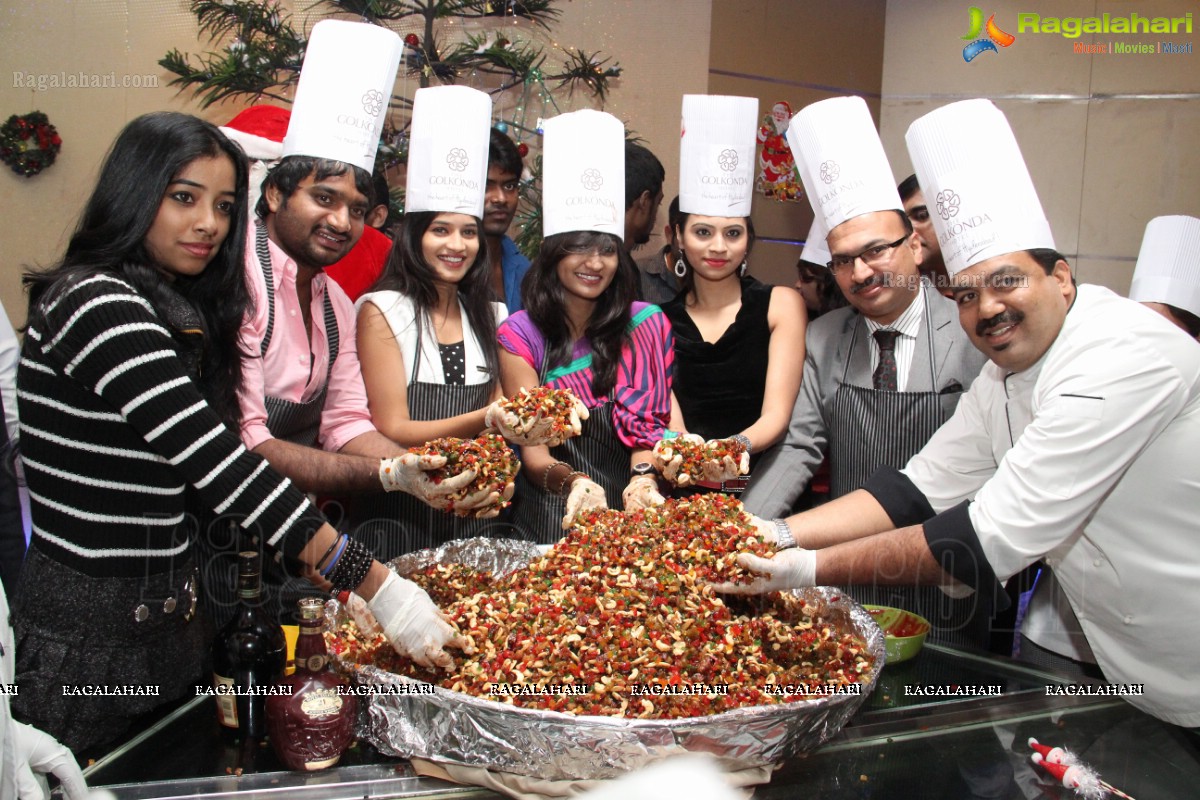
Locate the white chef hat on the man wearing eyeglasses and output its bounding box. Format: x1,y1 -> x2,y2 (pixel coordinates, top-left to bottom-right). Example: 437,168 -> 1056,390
787,97 -> 904,231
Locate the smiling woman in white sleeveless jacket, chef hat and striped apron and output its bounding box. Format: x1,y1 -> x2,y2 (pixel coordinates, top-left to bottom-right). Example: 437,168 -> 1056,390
350,86 -> 512,559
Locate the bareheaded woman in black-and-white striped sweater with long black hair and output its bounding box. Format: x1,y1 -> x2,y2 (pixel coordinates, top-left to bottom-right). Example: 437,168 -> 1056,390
13,113 -> 457,751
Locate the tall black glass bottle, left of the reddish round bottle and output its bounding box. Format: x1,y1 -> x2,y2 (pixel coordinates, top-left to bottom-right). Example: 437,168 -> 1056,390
212,551 -> 287,770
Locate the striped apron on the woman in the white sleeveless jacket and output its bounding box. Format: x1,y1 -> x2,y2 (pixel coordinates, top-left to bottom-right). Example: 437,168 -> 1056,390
350,316 -> 514,561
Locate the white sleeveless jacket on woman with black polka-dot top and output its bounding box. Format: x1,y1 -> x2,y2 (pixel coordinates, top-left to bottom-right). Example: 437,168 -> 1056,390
354,290 -> 509,386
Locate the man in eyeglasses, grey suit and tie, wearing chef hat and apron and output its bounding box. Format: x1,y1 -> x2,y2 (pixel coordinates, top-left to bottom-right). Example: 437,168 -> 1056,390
742,97 -> 990,646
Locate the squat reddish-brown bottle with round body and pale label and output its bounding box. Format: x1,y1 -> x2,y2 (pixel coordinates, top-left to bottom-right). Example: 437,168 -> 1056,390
266,597 -> 358,771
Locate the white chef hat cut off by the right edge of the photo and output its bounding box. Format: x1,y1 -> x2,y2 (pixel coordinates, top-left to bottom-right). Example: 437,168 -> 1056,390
1129,216 -> 1200,315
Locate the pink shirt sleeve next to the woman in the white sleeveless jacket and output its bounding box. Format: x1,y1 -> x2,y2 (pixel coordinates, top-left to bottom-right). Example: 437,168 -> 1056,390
317,278 -> 376,452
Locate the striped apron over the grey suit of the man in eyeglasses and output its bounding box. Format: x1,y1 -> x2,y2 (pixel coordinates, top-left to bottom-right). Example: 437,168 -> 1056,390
829,303 -> 991,648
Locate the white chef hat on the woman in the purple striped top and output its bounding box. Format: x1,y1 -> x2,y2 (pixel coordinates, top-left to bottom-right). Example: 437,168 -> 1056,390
541,108 -> 625,239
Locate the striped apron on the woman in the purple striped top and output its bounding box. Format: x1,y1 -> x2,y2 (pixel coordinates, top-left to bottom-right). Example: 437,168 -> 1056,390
512,401 -> 629,545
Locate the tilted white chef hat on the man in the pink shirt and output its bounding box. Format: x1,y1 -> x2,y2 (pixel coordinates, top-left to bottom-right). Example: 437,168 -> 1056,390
283,19 -> 404,173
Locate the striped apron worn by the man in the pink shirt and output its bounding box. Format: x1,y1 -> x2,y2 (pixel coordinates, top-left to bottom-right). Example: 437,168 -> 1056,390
197,222 -> 341,630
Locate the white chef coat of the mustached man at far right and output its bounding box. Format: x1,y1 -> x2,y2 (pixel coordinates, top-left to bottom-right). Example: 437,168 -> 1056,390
904,285 -> 1200,727
